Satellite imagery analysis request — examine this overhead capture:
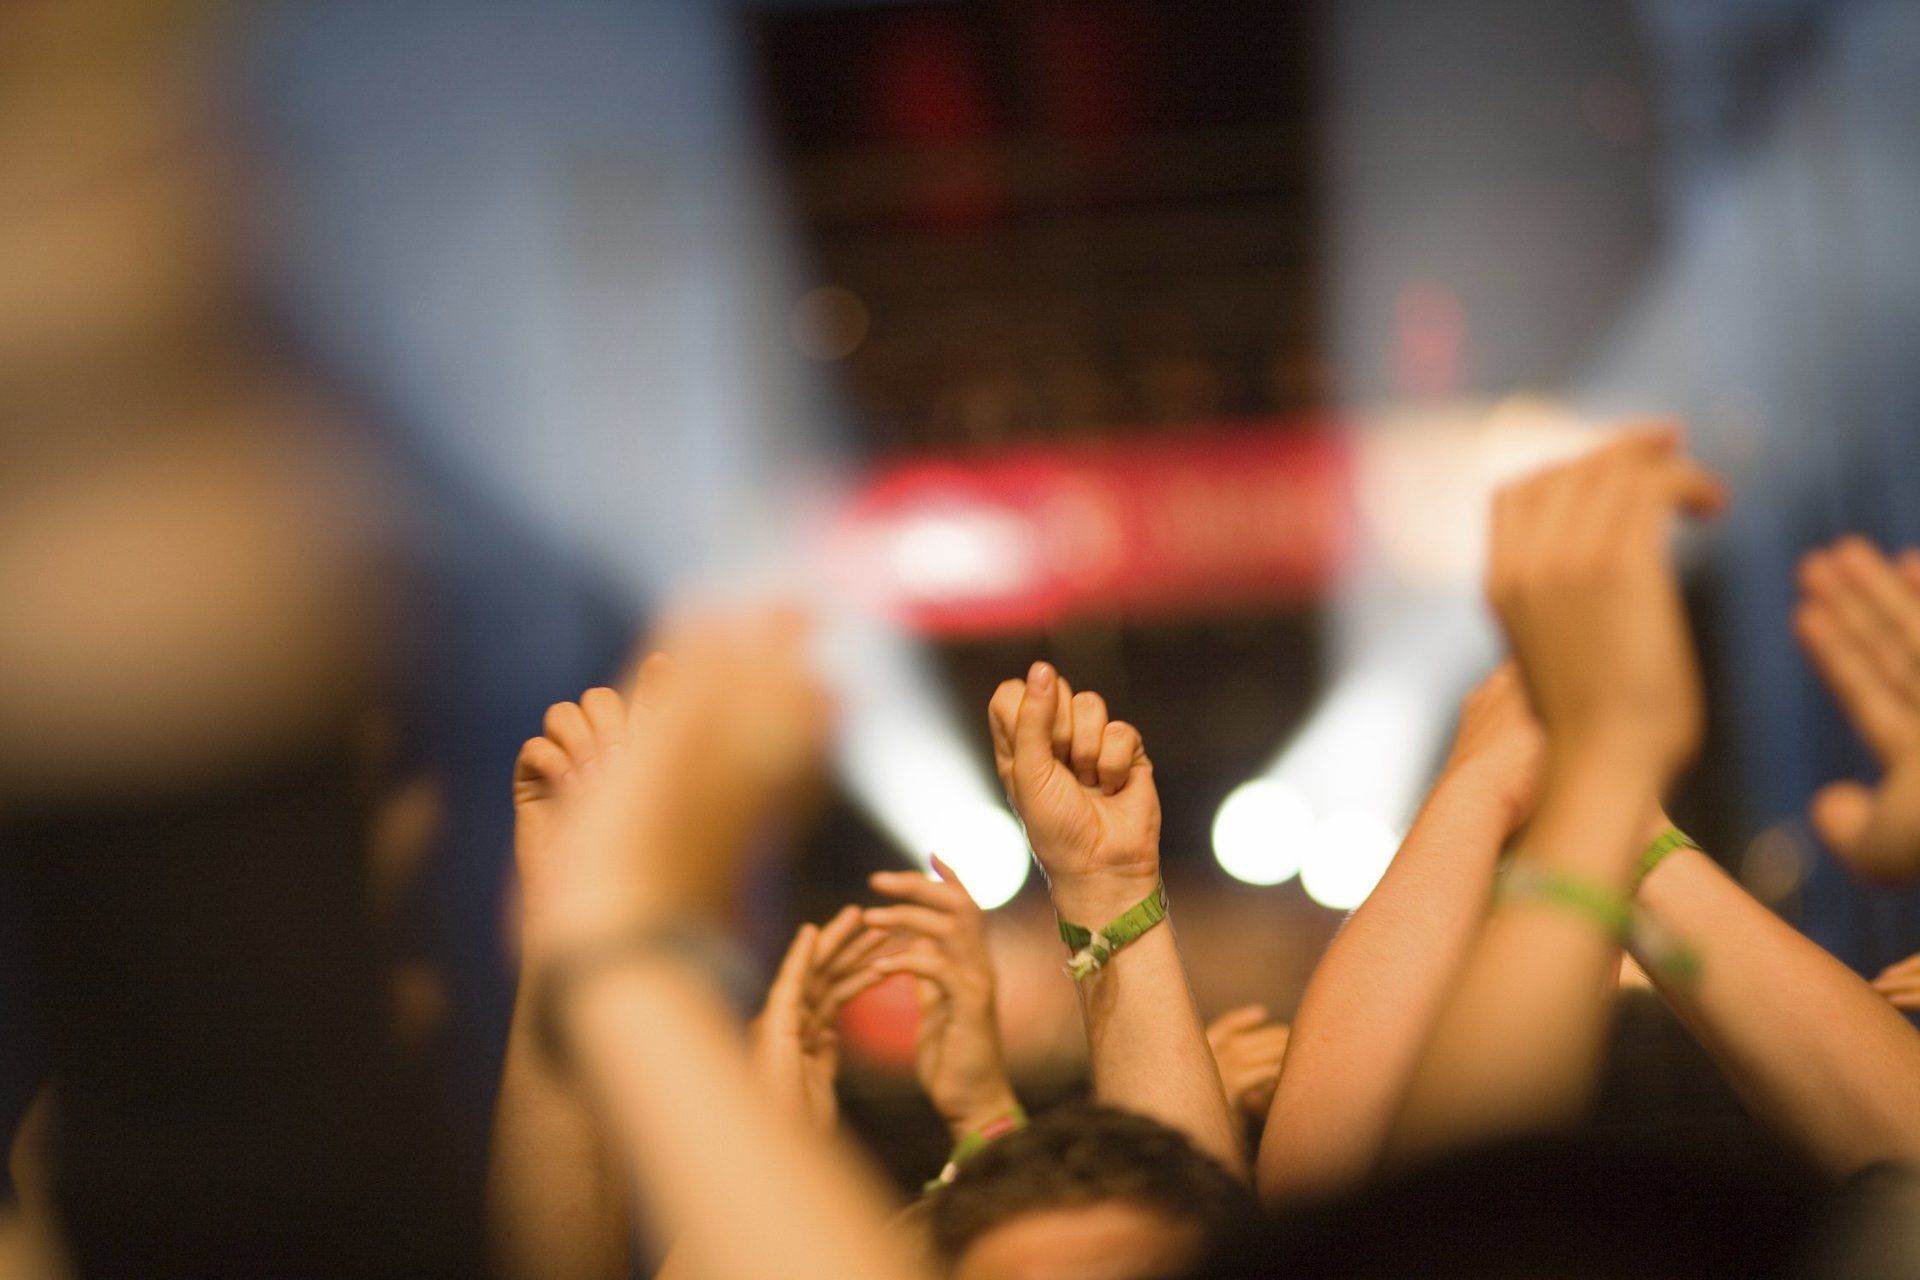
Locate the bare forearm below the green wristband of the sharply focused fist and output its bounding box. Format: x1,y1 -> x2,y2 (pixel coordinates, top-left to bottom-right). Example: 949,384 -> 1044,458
1069,902 -> 1246,1174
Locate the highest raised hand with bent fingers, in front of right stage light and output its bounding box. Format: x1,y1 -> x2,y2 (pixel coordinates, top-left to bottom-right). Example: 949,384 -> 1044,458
1486,428 -> 1724,789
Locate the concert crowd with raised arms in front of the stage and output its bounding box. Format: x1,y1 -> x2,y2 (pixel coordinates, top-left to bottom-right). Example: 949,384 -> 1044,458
11,0 -> 1920,1280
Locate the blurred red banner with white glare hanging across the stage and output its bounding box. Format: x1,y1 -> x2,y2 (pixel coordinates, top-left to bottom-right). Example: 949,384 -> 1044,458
828,422 -> 1352,635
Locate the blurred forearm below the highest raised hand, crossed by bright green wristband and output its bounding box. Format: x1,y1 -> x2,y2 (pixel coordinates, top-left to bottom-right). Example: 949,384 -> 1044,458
1388,760 -> 1653,1159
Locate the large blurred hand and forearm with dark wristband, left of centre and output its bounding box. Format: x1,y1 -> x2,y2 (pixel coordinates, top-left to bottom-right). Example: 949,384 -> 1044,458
495,614 -> 920,1280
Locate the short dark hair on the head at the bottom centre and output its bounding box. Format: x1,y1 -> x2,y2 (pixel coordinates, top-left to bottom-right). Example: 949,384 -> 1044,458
929,1103 -> 1254,1261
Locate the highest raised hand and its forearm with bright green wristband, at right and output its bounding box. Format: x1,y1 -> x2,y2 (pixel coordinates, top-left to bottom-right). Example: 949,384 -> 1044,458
1390,430 -> 1724,1157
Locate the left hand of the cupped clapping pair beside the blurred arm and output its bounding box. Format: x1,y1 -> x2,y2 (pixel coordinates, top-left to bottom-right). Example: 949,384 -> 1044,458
749,906 -> 887,1132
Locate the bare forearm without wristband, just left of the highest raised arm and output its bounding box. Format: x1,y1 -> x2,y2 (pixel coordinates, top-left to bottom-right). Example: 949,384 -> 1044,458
1258,775 -> 1509,1199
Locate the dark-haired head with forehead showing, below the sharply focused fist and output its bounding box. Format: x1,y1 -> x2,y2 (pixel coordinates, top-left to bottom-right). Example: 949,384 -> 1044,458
929,1103 -> 1254,1278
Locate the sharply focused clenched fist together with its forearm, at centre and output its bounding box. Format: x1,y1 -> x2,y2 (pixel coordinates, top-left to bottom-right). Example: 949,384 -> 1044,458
989,662 -> 1246,1173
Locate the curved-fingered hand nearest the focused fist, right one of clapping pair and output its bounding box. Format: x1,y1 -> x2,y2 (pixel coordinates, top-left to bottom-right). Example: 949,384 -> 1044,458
862,858 -> 1018,1142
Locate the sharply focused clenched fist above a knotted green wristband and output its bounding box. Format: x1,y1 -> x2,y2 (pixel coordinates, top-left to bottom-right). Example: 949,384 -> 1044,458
987,662 -> 1160,929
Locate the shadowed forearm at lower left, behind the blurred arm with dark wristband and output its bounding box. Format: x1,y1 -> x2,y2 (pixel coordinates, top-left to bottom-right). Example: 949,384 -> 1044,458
488,984 -> 632,1280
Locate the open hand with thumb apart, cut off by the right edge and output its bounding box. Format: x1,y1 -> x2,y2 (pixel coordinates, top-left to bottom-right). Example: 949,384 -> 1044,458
1793,537 -> 1920,881
